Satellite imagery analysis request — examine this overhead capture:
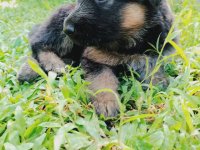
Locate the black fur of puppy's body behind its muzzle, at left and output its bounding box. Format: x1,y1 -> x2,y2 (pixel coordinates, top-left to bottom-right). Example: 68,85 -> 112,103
29,5 -> 84,65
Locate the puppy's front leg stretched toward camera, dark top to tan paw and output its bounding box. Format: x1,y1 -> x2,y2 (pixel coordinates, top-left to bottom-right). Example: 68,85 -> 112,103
82,59 -> 119,117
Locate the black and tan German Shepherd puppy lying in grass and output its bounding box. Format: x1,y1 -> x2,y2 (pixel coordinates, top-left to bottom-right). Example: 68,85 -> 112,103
18,0 -> 176,117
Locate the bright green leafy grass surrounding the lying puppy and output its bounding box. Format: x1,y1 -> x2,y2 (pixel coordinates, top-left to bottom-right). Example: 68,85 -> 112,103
0,0 -> 200,150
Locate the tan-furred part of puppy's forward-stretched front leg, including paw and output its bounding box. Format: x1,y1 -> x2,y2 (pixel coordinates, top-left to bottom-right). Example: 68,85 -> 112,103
86,67 -> 119,117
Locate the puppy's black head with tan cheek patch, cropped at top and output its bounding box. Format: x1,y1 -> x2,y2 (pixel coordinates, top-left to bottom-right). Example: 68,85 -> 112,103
64,0 -> 161,46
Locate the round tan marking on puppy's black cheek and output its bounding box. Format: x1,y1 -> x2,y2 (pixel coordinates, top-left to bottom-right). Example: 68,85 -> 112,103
122,3 -> 145,30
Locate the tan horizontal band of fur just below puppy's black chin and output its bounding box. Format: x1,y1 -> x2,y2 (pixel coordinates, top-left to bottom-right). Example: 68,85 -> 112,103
83,47 -> 145,66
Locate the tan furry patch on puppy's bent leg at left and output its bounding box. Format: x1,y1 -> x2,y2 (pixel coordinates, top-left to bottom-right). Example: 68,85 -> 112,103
38,51 -> 65,73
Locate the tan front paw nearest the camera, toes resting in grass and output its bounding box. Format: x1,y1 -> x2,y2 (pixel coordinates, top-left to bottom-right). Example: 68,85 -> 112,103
93,92 -> 119,117
